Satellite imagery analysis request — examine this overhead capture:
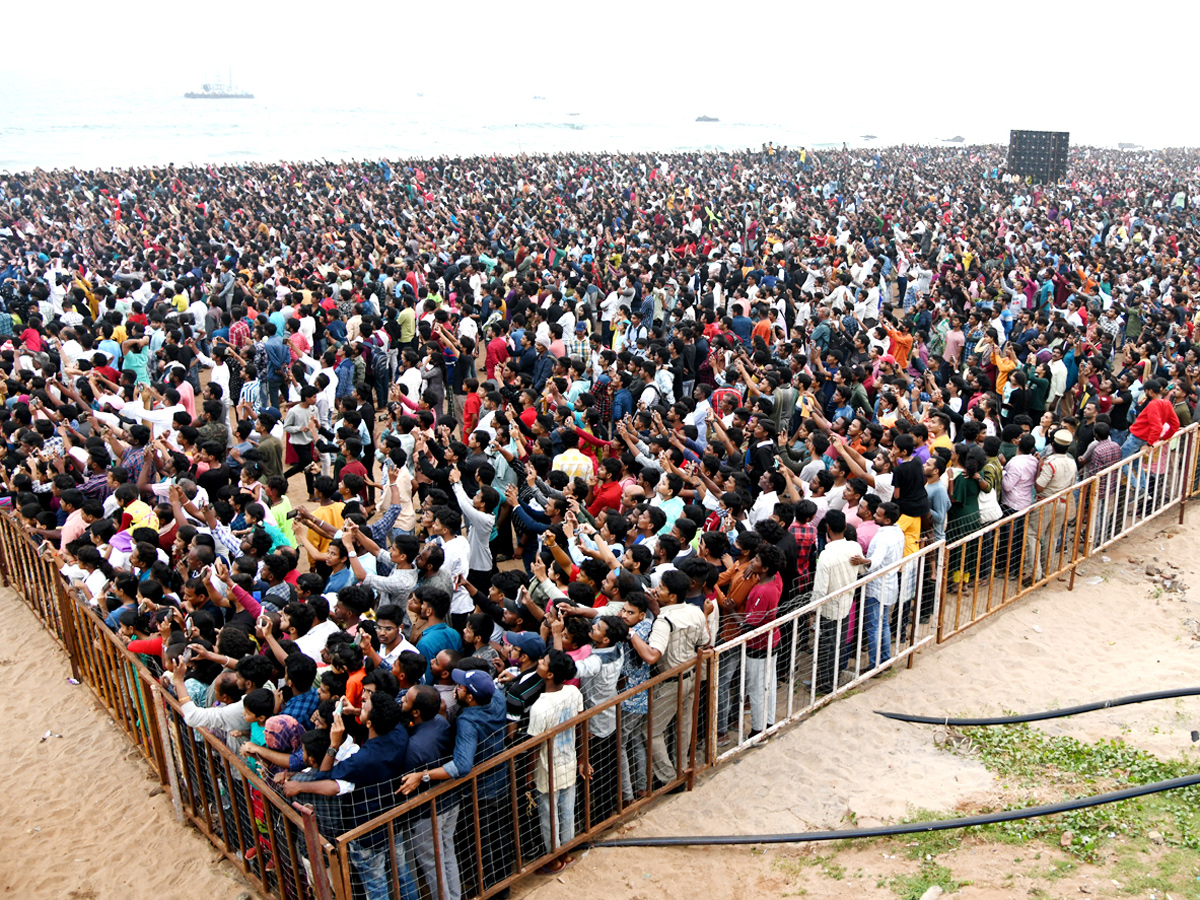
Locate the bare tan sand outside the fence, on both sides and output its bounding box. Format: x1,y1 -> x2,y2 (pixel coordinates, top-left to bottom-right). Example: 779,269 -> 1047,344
9,511 -> 1200,900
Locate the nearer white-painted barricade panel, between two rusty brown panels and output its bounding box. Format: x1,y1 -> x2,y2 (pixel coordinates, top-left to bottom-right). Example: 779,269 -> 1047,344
708,541 -> 946,762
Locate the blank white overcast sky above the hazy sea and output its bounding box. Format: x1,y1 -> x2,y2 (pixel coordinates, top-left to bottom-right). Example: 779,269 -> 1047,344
0,0 -> 1200,145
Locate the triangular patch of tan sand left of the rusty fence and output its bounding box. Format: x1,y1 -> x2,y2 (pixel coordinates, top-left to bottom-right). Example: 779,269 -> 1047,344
0,589 -> 247,900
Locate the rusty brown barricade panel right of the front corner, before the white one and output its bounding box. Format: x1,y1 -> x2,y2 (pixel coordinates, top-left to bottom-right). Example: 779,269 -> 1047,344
324,653 -> 709,900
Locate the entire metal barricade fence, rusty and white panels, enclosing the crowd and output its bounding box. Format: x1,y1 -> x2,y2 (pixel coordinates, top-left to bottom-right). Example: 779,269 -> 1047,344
7,425 -> 1200,900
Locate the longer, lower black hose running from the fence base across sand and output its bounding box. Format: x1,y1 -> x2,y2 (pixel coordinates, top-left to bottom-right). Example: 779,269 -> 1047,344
593,775 -> 1200,847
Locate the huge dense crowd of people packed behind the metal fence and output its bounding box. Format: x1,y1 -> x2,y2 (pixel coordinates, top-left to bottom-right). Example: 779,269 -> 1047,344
0,146 -> 1200,900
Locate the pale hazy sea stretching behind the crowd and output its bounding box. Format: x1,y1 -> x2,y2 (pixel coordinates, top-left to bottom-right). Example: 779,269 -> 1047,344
0,75 -> 1200,173
